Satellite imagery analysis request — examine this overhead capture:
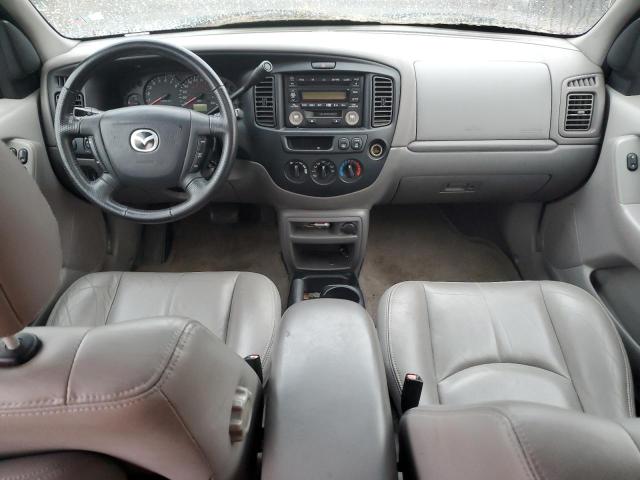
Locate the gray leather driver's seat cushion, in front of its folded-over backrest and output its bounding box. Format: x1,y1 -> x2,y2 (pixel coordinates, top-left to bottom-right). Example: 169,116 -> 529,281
48,272 -> 281,371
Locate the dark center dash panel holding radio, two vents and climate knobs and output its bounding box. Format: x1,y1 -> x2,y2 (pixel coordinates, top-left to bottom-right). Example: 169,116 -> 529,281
250,58 -> 400,197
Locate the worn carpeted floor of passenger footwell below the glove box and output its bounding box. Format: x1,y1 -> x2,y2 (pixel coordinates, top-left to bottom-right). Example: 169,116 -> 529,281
359,206 -> 520,315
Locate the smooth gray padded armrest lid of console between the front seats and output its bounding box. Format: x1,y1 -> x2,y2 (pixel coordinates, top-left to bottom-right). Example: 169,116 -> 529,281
262,299 -> 397,480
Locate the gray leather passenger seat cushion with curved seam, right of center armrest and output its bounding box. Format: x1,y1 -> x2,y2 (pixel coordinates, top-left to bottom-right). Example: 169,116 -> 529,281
378,282 -> 634,418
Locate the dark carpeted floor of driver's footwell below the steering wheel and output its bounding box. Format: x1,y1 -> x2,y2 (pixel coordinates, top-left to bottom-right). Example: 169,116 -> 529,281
138,209 -> 289,307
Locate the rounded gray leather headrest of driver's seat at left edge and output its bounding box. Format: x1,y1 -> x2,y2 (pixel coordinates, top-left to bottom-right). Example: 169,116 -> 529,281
0,144 -> 62,337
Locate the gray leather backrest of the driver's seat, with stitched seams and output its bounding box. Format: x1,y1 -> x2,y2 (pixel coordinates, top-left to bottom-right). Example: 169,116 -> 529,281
0,317 -> 262,480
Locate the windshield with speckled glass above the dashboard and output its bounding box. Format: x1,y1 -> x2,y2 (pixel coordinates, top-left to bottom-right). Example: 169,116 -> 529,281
31,0 -> 615,38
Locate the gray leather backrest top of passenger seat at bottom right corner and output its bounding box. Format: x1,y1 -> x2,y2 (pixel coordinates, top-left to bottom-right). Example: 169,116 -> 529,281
400,402 -> 640,480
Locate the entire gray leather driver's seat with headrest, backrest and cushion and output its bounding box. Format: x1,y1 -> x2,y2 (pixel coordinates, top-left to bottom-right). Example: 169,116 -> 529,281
0,143 -> 281,480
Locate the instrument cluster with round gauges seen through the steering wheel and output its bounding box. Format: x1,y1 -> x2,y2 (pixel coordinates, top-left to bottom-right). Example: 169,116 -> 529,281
124,72 -> 236,114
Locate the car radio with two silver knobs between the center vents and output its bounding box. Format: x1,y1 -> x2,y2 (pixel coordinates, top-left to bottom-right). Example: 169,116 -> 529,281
284,72 -> 364,128
